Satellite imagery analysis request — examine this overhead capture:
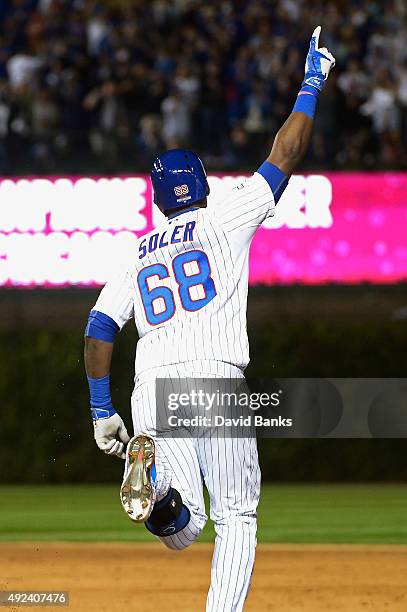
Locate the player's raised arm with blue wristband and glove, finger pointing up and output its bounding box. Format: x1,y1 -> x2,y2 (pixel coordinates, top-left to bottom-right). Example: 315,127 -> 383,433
267,26 -> 335,196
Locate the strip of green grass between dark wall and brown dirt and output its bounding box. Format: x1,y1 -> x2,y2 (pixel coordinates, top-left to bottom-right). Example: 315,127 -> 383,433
0,485 -> 407,544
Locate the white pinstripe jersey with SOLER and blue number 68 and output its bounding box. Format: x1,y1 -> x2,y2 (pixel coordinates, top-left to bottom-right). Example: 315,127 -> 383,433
94,172 -> 274,375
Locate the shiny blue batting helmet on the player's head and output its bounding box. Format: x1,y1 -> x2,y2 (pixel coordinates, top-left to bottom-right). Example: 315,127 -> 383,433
150,149 -> 209,212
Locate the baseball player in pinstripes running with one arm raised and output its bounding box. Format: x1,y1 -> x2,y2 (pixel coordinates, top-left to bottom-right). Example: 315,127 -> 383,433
85,27 -> 335,612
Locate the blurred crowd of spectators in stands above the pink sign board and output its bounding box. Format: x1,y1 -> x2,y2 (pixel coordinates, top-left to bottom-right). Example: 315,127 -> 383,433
0,0 -> 407,174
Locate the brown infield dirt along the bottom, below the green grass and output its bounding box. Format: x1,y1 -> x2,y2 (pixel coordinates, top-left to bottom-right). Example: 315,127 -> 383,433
0,542 -> 407,612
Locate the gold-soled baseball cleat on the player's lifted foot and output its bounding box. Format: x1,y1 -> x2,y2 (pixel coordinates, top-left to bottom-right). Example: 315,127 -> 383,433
120,434 -> 155,523
